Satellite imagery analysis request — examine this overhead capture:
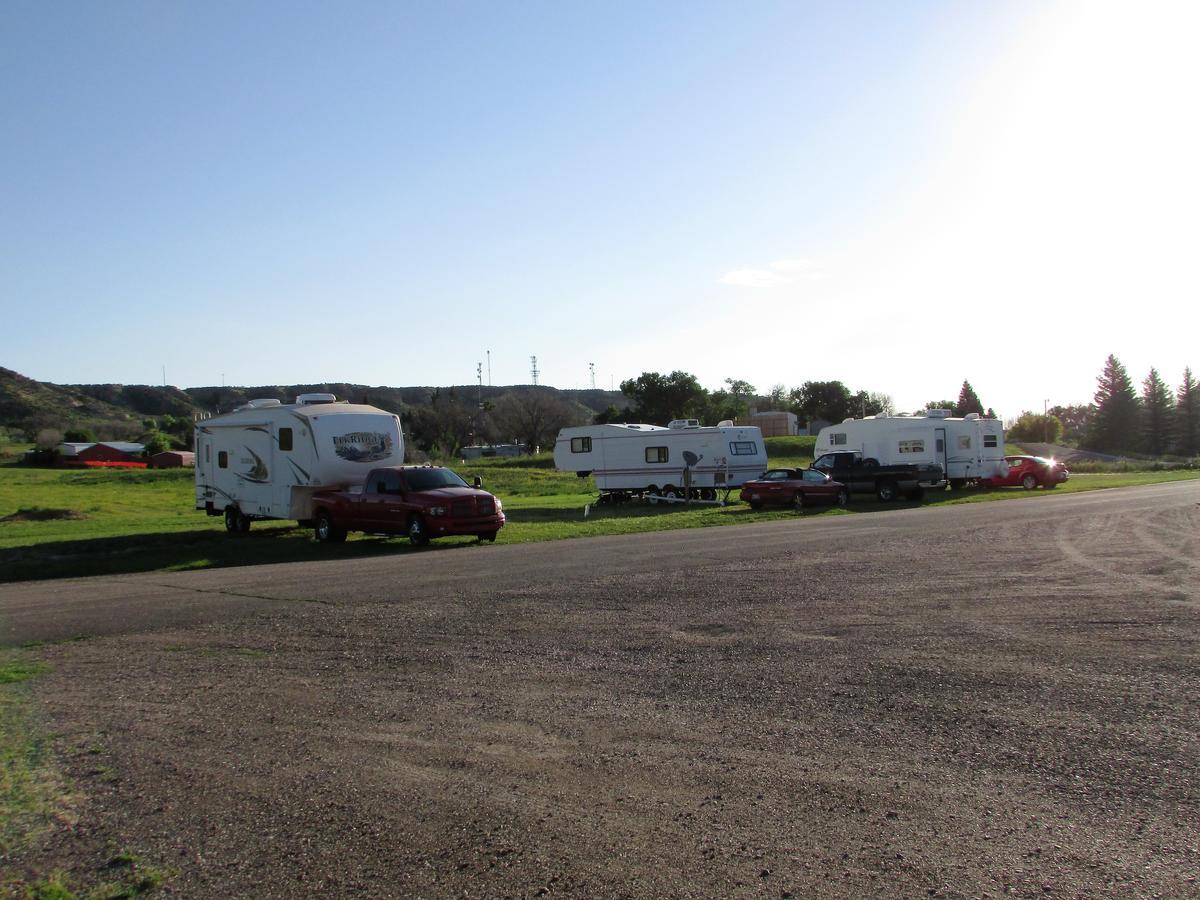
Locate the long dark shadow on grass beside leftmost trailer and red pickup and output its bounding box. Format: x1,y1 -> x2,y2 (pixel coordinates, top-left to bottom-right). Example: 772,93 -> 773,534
0,528 -> 474,583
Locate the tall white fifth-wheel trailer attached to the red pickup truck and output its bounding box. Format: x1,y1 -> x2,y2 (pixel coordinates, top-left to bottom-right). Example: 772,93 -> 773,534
196,394 -> 404,532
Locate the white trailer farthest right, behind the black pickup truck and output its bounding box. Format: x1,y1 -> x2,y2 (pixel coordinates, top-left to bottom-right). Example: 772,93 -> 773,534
814,409 -> 1008,487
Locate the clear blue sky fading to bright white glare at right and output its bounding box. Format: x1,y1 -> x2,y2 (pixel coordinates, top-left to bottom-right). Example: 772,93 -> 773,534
0,0 -> 1200,418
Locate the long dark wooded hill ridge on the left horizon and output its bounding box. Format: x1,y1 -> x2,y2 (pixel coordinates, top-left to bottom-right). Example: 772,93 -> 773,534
0,367 -> 628,440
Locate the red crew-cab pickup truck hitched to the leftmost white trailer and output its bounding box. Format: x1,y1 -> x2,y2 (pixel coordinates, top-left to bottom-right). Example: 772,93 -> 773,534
312,466 -> 504,546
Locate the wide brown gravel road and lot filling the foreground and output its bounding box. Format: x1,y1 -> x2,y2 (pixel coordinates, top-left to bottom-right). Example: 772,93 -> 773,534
0,481 -> 1200,898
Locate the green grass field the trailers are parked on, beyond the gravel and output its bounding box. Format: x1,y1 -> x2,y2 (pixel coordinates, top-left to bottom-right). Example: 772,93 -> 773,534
0,437 -> 1200,582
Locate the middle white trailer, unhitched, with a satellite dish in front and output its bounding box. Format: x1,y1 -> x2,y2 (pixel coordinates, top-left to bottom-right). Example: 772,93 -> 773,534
554,419 -> 767,500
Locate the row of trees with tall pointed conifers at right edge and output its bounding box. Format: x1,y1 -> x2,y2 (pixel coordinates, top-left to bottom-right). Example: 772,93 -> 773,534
1008,354 -> 1200,457
